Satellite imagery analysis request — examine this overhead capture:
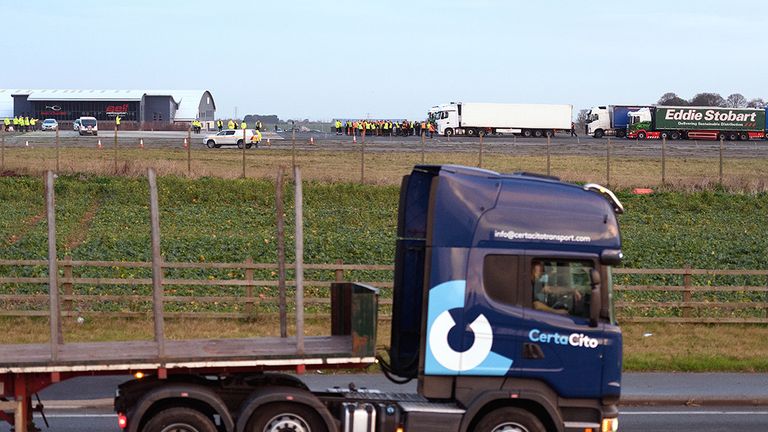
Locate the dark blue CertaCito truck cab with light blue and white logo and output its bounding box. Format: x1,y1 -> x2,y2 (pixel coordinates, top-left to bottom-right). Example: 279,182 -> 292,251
385,165 -> 623,432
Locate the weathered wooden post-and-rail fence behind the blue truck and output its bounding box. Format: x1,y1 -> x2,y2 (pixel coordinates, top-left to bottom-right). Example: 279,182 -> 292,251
0,257 -> 768,324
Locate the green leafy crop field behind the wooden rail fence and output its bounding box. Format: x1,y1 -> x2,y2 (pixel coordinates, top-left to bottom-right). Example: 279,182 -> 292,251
0,174 -> 768,370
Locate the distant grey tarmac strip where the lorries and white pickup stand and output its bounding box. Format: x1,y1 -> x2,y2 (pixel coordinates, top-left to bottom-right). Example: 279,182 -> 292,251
5,130 -> 768,158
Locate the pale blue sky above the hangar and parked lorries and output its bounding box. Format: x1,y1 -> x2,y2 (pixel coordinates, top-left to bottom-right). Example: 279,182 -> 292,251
0,0 -> 768,120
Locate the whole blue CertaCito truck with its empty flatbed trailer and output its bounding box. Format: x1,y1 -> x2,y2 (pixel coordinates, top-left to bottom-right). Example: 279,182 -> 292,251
0,165 -> 623,432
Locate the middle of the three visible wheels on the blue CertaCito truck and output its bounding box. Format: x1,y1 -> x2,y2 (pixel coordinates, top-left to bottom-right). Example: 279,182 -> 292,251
245,403 -> 327,432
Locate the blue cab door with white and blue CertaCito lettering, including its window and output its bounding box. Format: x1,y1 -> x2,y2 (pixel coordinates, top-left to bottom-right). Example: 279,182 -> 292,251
516,253 -> 605,397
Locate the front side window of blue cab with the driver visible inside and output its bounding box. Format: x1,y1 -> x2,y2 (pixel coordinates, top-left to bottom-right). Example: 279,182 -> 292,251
531,259 -> 594,318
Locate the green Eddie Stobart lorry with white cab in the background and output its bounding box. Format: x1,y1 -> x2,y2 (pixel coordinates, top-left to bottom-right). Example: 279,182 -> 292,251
627,106 -> 766,141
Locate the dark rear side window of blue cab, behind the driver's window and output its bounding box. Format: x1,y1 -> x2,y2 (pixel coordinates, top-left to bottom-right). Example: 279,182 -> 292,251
483,255 -> 523,305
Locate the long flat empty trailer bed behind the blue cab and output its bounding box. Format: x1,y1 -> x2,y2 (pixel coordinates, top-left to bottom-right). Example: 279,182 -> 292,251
0,335 -> 374,373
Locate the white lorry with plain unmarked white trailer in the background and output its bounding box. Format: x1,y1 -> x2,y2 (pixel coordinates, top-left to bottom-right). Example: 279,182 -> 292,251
429,102 -> 573,137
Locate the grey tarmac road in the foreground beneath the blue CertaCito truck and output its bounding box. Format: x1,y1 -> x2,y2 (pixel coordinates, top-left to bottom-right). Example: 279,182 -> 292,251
0,373 -> 768,432
